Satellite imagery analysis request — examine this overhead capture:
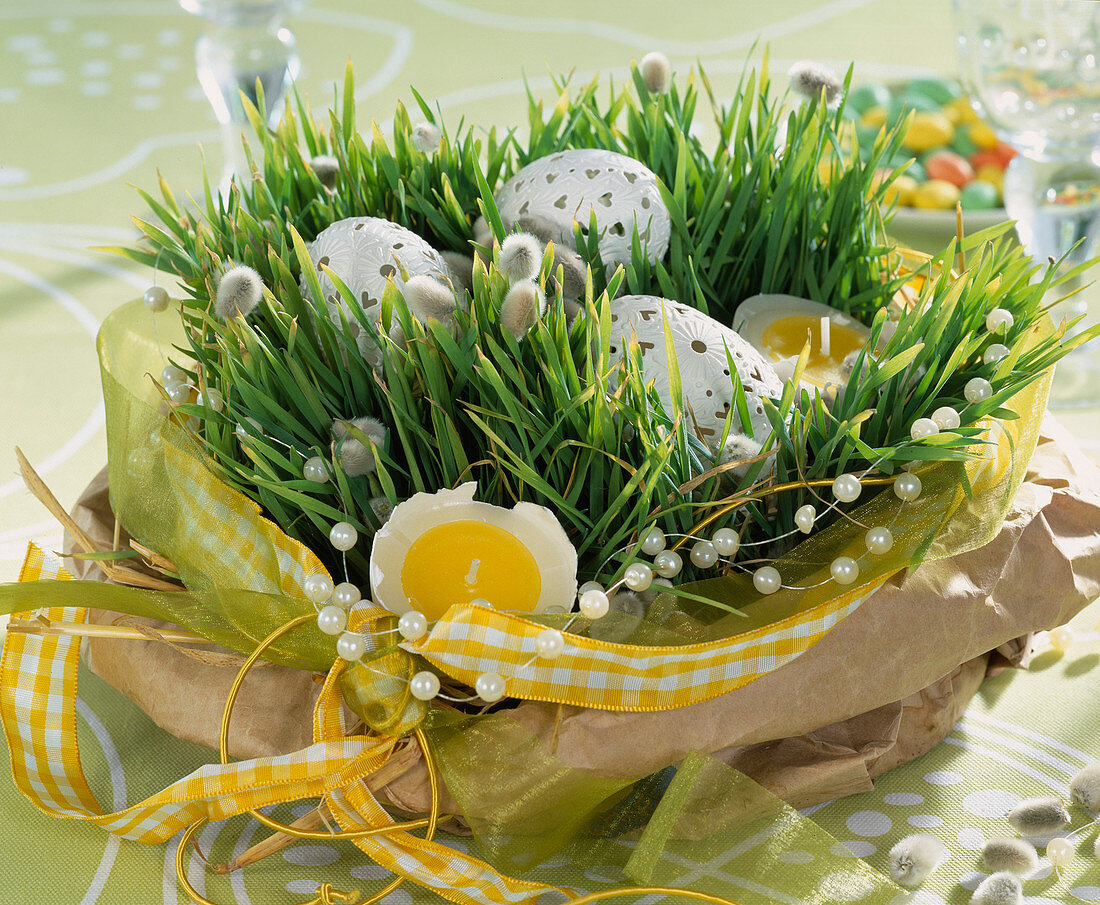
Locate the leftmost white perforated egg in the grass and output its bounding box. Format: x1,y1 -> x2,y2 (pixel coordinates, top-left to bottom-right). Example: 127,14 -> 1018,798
301,217 -> 451,323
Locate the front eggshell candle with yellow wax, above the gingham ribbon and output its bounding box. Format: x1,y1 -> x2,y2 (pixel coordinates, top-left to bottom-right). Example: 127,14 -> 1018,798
371,482 -> 576,621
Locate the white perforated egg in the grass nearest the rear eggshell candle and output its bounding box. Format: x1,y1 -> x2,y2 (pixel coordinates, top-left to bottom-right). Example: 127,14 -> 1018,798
611,296 -> 783,449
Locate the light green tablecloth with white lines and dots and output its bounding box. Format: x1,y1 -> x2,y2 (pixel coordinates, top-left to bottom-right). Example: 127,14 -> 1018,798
0,0 -> 1100,905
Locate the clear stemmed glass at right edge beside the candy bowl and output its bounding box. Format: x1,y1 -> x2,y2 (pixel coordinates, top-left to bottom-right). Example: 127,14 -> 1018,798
954,0 -> 1100,406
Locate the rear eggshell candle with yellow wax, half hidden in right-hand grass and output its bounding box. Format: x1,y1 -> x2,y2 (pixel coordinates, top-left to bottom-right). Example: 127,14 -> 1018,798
734,295 -> 871,388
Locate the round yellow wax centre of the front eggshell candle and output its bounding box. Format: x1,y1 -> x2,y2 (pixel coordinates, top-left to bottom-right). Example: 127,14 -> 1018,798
402,519 -> 542,621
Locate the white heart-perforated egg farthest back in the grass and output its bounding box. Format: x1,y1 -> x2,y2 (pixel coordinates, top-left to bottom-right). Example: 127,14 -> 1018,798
495,147 -> 671,266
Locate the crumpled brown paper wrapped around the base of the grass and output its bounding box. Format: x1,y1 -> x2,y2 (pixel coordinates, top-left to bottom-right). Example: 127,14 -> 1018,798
66,416 -> 1100,813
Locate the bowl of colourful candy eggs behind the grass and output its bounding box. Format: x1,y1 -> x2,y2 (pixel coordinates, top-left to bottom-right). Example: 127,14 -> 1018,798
846,77 -> 1015,251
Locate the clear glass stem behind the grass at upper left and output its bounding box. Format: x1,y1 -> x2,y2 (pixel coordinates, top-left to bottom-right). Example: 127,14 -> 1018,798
179,0 -> 306,189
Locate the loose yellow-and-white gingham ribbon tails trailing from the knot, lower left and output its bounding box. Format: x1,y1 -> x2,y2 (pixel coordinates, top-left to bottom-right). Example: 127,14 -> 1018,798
0,544 -> 554,905
